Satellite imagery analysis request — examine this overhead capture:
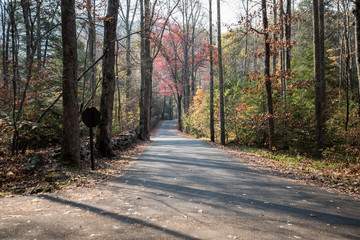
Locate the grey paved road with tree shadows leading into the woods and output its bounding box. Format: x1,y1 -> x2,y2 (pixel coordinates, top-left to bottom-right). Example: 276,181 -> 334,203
0,121 -> 360,240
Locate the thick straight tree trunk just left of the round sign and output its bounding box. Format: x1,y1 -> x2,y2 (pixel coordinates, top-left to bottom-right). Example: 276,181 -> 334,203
61,0 -> 80,165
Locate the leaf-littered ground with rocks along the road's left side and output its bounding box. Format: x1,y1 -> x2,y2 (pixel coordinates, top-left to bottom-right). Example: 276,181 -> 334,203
0,138 -> 149,197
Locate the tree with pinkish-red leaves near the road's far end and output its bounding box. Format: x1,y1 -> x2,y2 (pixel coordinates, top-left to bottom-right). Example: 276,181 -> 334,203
154,19 -> 208,131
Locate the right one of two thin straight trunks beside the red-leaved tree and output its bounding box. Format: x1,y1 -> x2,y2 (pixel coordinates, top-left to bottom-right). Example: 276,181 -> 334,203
217,0 -> 225,145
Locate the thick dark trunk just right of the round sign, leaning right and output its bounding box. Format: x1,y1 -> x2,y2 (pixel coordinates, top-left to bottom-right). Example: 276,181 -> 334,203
96,0 -> 119,157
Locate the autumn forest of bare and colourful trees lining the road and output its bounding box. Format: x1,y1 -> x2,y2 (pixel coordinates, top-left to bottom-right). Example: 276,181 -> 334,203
0,0 -> 360,195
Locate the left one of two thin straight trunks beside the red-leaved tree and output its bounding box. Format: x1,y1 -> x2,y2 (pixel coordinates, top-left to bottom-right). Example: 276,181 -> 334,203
209,0 -> 215,142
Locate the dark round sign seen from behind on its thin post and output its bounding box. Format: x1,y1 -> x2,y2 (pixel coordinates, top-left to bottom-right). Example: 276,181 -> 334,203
81,107 -> 100,170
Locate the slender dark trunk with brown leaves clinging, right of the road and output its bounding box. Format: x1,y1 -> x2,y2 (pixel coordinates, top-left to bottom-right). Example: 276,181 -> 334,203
261,0 -> 275,151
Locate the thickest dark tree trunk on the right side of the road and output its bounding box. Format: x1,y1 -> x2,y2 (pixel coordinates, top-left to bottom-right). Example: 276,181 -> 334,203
313,0 -> 326,156
